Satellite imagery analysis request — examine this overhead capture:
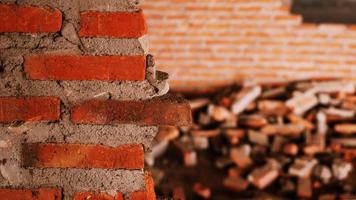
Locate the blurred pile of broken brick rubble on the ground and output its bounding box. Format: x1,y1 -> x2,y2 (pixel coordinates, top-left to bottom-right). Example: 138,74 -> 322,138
146,80 -> 356,199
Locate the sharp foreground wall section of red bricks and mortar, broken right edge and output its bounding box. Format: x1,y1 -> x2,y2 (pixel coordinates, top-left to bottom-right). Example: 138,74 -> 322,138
0,0 -> 191,200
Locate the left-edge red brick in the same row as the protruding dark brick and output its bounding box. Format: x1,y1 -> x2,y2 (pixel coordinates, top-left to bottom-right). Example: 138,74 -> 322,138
0,97 -> 60,122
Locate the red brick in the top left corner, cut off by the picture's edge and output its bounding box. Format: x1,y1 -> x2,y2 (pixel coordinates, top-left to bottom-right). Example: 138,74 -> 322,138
0,4 -> 62,33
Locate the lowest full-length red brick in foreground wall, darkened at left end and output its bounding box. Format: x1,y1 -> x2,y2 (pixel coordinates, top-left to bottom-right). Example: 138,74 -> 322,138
23,143 -> 144,169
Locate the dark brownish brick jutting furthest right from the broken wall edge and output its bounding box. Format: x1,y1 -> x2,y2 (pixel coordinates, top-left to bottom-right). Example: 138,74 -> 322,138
71,95 -> 192,126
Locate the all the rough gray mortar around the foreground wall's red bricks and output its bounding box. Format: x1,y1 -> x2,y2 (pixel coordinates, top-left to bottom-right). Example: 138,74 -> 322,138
0,0 -> 169,199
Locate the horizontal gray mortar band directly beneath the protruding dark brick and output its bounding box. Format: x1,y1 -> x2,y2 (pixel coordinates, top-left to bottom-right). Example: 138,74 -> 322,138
0,120 -> 158,149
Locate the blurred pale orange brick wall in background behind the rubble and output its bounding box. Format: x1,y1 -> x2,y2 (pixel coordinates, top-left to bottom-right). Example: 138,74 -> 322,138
143,0 -> 356,90
